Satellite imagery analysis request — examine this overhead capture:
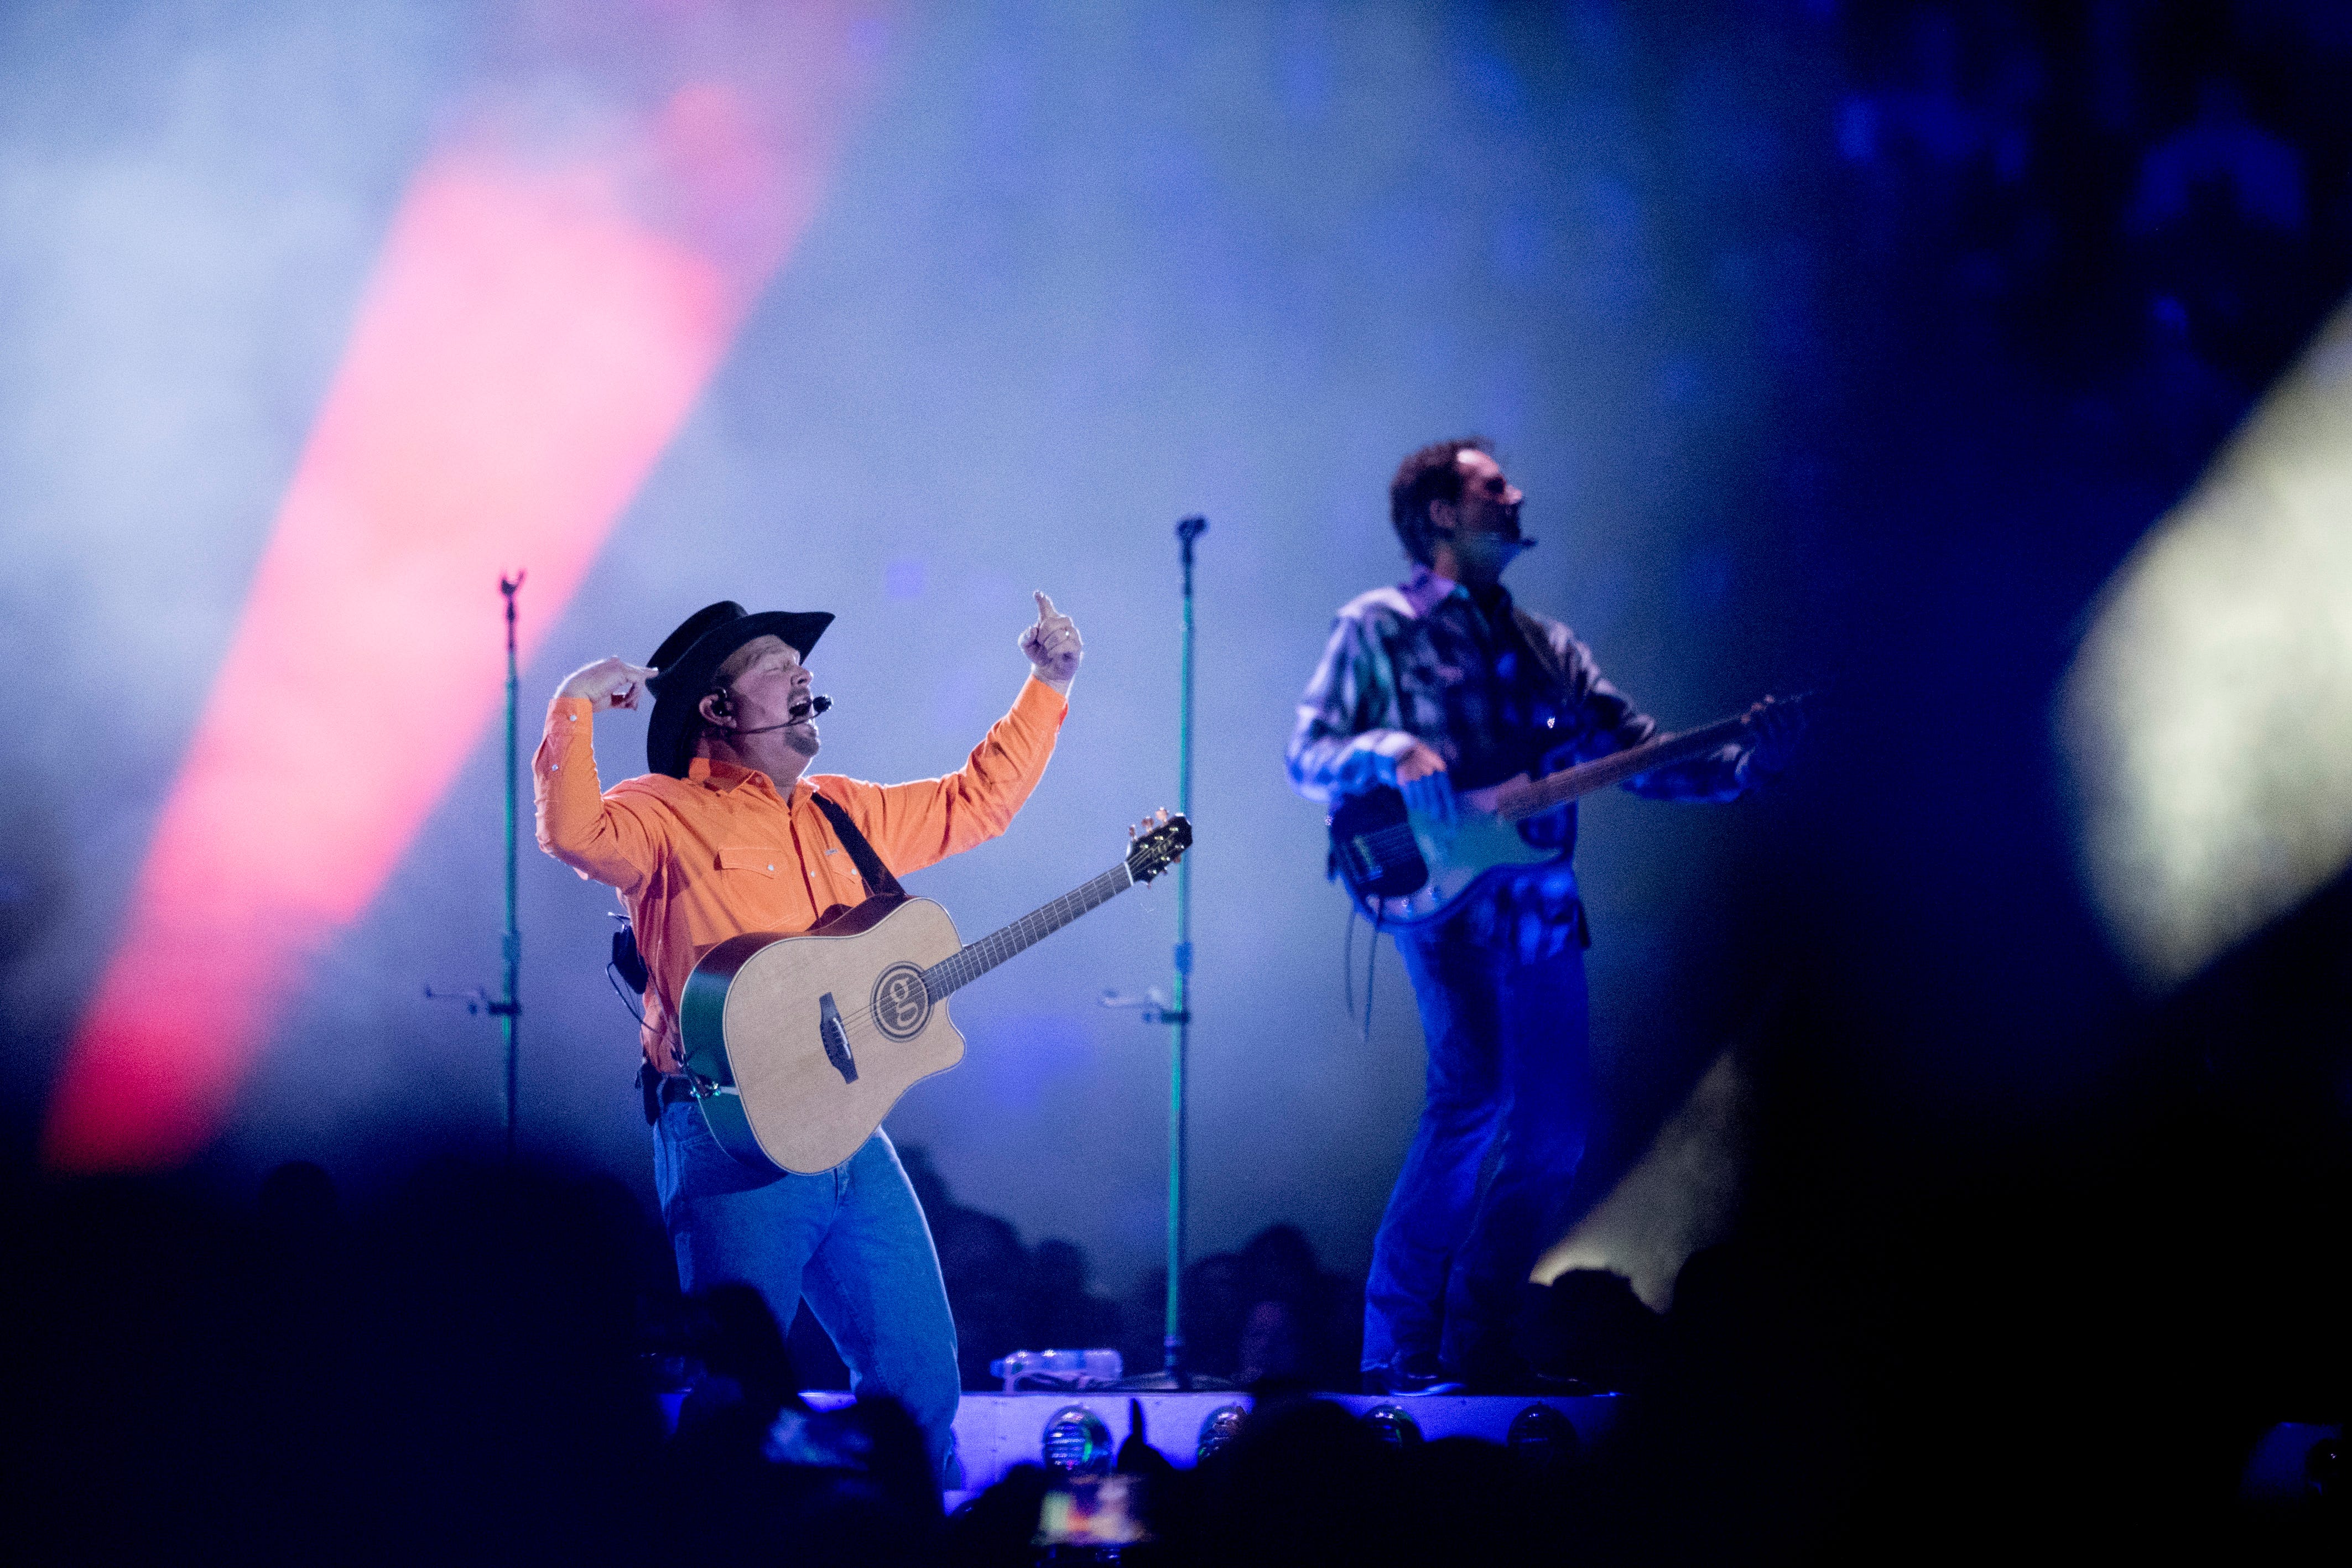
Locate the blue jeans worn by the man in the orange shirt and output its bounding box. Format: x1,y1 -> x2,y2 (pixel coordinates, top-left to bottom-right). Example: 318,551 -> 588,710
654,1102 -> 962,1483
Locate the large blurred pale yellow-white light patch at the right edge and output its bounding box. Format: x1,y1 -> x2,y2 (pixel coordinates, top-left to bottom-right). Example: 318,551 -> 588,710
2053,294 -> 2352,989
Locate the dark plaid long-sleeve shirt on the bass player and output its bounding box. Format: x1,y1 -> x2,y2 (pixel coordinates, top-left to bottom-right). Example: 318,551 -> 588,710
1289,566 -> 1747,945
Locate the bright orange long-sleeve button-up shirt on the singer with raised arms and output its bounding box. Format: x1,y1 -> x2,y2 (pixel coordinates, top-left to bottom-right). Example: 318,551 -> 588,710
532,677 -> 1070,1072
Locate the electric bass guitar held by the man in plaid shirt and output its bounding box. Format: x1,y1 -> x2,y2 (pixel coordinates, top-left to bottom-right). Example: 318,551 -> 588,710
1326,698 -> 1799,926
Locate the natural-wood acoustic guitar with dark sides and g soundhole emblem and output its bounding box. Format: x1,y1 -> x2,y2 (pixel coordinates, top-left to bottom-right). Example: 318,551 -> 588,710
678,816 -> 1193,1175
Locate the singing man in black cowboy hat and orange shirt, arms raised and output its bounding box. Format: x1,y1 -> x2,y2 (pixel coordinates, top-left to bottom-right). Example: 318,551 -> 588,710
532,592 -> 1084,1483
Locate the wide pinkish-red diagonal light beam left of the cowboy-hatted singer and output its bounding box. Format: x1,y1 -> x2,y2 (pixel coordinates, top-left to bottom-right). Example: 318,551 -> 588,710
43,43 -> 875,1171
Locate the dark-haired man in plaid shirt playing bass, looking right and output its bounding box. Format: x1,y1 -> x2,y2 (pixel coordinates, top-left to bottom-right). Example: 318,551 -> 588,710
1289,437 -> 1797,1394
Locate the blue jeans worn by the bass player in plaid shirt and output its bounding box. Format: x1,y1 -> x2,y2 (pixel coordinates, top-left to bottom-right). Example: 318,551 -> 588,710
1364,914 -> 1593,1378
